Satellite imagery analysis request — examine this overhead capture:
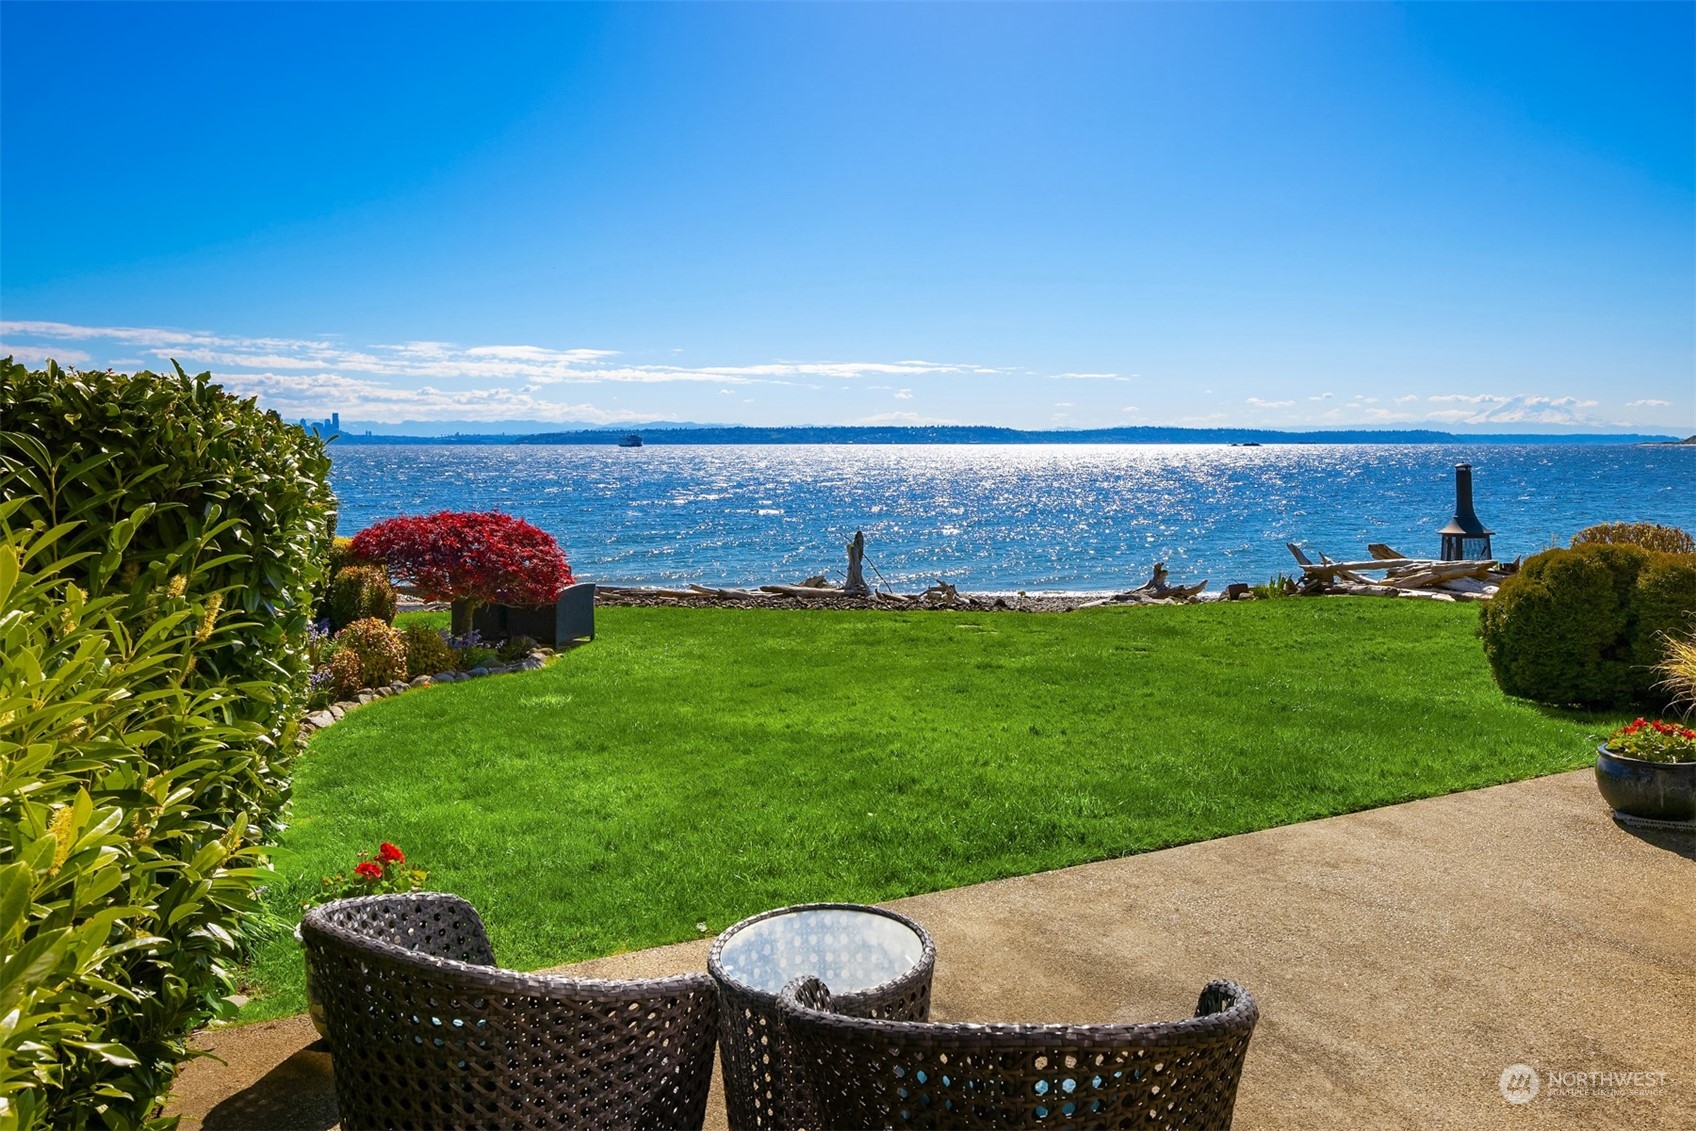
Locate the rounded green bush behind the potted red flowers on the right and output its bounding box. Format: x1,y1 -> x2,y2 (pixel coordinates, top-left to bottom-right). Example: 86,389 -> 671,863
1479,543 -> 1696,707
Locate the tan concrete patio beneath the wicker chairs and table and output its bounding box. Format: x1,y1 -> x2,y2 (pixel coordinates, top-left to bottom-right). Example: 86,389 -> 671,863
168,770 -> 1696,1131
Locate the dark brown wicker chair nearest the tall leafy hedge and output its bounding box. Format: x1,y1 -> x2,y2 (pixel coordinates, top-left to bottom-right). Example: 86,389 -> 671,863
300,894 -> 719,1131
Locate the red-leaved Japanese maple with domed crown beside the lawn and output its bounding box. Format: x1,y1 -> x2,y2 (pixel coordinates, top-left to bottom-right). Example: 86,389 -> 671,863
348,510 -> 572,632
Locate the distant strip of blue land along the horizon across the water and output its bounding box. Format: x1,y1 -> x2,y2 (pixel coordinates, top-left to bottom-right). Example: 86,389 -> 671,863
336,421 -> 1696,446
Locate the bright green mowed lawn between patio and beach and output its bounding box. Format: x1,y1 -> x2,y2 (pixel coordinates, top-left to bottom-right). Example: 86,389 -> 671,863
244,599 -> 1613,1019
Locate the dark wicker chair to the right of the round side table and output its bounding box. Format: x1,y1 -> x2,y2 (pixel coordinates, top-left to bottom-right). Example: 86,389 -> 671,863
778,978 -> 1260,1131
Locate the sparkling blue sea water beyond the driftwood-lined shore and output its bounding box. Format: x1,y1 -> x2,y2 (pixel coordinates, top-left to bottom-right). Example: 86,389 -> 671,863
331,444 -> 1696,592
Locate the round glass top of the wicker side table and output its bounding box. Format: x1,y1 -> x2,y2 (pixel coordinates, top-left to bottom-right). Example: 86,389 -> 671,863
719,907 -> 924,994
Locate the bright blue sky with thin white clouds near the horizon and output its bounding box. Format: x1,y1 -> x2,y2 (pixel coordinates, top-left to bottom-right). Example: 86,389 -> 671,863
0,2 -> 1696,434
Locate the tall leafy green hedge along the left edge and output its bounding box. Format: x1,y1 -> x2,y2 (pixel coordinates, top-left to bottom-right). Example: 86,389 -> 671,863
0,359 -> 334,1128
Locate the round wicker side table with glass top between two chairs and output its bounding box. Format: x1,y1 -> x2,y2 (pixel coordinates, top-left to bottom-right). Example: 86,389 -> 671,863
707,904 -> 936,1131
